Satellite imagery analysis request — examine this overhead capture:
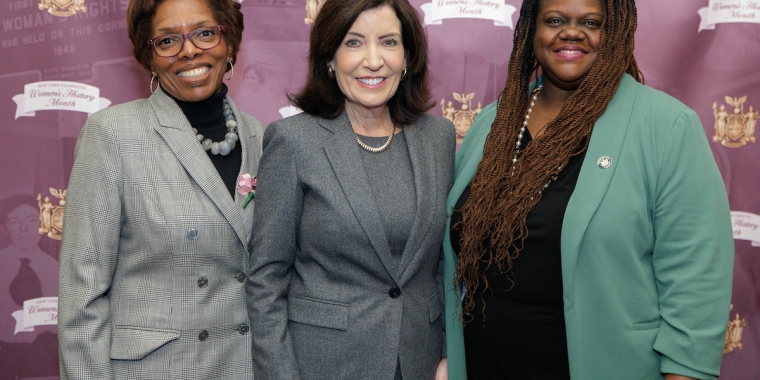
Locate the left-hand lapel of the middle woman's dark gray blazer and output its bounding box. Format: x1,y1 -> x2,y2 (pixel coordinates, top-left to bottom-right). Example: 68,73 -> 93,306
319,111 -> 398,283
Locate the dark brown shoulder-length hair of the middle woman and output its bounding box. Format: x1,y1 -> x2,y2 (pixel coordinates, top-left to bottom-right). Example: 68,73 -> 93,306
290,0 -> 433,125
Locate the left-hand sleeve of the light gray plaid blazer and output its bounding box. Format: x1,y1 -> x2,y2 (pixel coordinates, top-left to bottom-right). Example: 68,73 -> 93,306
58,113 -> 122,379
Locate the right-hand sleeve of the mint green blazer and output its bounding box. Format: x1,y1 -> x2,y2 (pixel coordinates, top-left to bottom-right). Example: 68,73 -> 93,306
652,110 -> 734,379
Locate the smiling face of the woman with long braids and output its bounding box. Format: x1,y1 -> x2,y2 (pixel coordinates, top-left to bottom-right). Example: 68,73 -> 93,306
533,0 -> 604,91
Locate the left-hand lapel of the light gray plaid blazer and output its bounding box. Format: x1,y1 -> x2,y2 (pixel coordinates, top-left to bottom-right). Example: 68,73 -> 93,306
149,91 -> 250,250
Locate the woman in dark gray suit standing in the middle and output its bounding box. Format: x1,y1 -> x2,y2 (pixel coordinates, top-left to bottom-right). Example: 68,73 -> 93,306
246,0 -> 456,380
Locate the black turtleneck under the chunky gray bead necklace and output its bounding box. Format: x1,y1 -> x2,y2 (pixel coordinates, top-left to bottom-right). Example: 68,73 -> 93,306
161,84 -> 243,199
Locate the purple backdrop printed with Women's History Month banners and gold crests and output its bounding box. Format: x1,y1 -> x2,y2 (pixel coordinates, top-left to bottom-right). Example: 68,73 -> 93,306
0,0 -> 760,379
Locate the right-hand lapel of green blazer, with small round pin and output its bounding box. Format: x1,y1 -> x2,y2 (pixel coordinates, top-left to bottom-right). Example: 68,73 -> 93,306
561,74 -> 637,289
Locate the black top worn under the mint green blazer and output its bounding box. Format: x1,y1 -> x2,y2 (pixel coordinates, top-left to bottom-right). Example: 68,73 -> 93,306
451,133 -> 585,380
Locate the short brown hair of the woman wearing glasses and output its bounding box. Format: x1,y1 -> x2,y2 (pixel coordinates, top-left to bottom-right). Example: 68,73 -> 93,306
127,0 -> 244,71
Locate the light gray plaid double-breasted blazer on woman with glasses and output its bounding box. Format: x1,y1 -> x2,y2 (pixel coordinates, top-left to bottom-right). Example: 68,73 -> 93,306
58,87 -> 263,379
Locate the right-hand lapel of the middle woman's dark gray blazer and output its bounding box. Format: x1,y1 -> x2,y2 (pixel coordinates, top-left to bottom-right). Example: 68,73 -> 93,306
398,123 -> 438,278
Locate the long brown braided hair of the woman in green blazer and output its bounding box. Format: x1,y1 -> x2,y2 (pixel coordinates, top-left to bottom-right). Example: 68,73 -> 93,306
455,0 -> 643,322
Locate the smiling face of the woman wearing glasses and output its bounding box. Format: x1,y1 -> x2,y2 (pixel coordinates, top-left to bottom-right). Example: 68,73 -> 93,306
152,0 -> 232,102
